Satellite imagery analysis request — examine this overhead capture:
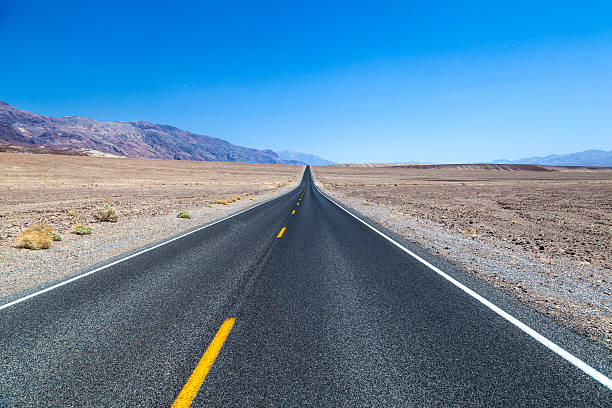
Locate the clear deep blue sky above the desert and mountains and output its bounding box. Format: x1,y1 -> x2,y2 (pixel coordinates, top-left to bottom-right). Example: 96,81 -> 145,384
0,0 -> 612,162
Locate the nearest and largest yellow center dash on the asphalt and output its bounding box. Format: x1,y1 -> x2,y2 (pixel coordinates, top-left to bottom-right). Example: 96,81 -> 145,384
172,318 -> 236,408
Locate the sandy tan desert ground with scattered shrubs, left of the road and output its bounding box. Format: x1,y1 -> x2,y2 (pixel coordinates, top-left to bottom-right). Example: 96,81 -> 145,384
0,153 -> 304,296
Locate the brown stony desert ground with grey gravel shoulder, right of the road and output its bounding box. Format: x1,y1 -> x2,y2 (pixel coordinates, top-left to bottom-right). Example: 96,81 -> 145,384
313,165 -> 612,348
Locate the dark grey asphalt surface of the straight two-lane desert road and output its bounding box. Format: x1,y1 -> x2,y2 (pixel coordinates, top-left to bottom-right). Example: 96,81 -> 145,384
0,167 -> 612,407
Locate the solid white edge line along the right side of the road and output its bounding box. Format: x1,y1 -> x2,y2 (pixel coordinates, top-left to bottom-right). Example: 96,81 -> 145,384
312,181 -> 612,390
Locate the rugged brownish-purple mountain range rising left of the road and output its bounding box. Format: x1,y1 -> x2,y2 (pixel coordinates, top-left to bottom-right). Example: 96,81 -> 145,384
0,101 -> 301,164
